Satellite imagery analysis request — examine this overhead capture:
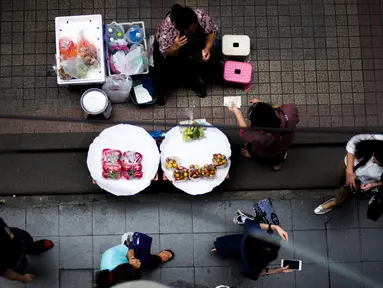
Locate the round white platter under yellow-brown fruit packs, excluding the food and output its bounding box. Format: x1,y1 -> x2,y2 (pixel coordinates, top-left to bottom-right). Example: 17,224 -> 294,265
160,126 -> 231,195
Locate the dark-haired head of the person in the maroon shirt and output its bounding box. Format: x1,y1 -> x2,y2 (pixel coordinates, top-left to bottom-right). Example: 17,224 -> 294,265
248,102 -> 281,128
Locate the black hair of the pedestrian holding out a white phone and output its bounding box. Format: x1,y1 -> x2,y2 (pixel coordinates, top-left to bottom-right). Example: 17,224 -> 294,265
245,236 -> 281,270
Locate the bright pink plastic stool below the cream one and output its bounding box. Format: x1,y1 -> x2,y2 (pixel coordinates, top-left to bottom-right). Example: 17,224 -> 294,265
223,60 -> 253,91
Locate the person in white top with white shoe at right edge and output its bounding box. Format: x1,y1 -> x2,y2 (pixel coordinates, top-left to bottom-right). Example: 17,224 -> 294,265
314,134 -> 383,215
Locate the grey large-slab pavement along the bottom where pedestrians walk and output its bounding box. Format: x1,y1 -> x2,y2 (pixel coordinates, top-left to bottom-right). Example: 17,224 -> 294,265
0,197 -> 383,288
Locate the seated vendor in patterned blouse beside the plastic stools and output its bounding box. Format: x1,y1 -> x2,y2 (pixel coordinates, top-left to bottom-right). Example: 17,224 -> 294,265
153,4 -> 222,105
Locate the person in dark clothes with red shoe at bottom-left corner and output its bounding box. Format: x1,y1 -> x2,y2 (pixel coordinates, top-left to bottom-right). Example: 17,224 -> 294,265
0,217 -> 53,283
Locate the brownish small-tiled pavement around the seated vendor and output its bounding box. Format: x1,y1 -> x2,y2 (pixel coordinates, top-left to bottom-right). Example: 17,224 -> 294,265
0,0 -> 383,133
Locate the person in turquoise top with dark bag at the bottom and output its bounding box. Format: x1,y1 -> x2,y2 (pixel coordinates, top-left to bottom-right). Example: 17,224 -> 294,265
96,232 -> 174,288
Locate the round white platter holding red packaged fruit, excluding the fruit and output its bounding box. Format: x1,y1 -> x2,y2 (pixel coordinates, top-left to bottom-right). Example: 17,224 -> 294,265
87,124 -> 160,196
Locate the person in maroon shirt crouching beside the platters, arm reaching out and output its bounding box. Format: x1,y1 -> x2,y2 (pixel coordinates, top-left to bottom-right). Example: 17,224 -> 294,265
228,99 -> 299,171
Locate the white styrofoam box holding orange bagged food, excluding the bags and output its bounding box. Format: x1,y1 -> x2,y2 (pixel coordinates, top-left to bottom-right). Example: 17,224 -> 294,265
55,15 -> 105,85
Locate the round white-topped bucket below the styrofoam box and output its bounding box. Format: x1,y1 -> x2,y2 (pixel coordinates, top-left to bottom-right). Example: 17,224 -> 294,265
80,88 -> 112,119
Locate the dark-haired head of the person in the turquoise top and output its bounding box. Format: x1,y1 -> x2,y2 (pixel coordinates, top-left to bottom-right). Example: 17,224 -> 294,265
96,263 -> 139,288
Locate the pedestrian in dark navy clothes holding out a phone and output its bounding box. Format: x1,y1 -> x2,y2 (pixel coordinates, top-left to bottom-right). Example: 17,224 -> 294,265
211,210 -> 292,280
